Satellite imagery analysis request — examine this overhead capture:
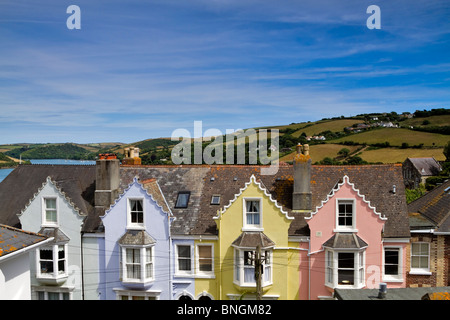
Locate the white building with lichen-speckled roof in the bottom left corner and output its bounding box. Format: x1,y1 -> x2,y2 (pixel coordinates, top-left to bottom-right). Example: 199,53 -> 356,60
0,225 -> 53,300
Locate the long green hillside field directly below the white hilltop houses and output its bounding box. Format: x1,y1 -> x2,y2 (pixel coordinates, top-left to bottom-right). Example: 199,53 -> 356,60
331,128 -> 450,147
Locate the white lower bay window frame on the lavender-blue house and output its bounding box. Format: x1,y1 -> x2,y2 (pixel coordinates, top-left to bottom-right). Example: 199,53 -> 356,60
121,245 -> 155,283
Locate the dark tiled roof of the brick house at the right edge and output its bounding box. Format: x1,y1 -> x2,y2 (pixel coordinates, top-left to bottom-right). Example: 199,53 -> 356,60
408,180 -> 450,232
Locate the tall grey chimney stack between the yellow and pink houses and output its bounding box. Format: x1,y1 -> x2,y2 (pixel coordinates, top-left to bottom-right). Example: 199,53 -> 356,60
292,144 -> 312,211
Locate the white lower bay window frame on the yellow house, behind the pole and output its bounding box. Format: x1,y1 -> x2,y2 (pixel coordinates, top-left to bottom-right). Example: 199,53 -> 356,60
233,248 -> 273,288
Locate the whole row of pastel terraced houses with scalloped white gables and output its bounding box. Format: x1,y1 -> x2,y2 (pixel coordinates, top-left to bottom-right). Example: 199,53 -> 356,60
0,146 -> 448,300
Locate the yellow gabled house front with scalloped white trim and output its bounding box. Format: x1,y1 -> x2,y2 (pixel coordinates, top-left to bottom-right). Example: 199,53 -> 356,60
209,175 -> 299,300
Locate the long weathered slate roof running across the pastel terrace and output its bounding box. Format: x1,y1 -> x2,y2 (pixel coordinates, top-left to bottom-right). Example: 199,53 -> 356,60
0,165 -> 409,237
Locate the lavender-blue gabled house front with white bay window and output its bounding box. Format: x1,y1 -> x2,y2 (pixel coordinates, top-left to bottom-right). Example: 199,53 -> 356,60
99,178 -> 173,300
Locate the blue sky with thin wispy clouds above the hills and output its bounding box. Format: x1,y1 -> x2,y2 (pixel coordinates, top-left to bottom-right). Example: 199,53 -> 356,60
0,0 -> 450,143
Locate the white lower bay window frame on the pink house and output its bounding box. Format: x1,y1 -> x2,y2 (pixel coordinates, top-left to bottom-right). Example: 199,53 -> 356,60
325,249 -> 366,289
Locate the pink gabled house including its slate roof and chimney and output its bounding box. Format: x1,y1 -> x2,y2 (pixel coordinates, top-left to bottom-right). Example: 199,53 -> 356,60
293,145 -> 409,300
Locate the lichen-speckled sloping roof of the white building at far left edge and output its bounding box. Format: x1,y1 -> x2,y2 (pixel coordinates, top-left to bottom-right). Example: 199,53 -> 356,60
0,225 -> 47,257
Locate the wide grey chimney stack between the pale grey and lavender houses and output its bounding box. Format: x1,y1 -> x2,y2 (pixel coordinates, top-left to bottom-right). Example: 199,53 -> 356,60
95,153 -> 120,213
